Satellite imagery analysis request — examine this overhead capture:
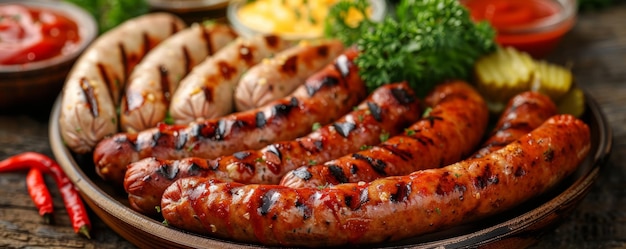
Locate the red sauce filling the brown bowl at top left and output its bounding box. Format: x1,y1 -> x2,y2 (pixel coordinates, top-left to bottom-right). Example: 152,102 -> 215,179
0,4 -> 80,65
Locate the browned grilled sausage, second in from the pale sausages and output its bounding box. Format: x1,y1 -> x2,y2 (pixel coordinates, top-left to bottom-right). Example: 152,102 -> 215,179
124,83 -> 421,215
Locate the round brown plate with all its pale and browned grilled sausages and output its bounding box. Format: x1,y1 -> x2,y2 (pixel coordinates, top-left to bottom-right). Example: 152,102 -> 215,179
49,13 -> 612,248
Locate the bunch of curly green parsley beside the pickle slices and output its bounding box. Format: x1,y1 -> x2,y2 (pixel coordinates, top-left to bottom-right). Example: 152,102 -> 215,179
325,0 -> 496,96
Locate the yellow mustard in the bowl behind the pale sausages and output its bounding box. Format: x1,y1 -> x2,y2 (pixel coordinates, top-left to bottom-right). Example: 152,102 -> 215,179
237,0 -> 363,38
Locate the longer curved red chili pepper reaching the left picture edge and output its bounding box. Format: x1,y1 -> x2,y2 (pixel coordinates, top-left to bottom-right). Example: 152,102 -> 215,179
0,152 -> 91,238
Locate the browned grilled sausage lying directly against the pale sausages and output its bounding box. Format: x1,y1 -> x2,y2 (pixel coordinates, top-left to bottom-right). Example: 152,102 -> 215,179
93,49 -> 367,187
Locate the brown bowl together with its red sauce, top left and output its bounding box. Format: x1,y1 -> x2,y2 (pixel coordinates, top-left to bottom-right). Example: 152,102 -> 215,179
0,0 -> 98,109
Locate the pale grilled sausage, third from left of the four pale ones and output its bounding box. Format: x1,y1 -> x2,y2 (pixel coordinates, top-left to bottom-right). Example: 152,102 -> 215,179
170,35 -> 291,124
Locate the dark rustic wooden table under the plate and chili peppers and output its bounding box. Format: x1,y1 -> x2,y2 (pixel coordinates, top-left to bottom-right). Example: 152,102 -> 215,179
0,4 -> 626,249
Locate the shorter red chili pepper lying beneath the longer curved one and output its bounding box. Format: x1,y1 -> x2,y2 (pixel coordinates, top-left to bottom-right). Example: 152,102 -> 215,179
26,168 -> 54,224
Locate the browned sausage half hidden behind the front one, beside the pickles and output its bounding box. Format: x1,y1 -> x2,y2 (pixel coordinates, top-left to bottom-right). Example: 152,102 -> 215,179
472,91 -> 558,157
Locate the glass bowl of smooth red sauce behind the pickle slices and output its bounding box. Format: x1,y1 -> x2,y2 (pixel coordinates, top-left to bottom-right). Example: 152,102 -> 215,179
461,0 -> 577,58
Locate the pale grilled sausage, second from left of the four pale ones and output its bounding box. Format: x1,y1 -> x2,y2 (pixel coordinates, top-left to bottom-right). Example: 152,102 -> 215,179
120,23 -> 237,132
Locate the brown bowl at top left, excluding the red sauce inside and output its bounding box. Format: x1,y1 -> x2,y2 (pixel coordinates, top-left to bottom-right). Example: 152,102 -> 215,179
0,0 -> 98,110
